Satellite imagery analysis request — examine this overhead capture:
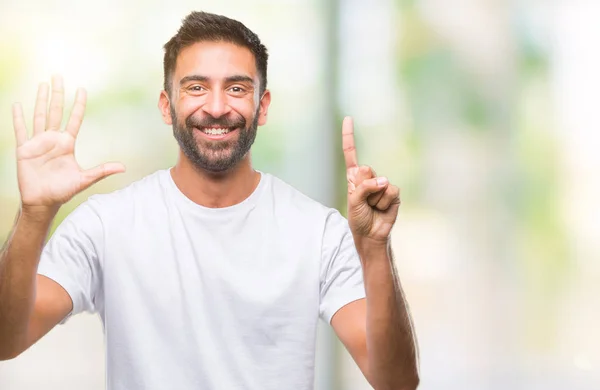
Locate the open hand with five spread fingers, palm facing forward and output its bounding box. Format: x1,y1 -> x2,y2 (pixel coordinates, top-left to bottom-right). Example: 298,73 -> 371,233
13,76 -> 125,212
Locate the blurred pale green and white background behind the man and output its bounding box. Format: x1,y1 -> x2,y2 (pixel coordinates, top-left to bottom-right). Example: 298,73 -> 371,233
0,0 -> 600,390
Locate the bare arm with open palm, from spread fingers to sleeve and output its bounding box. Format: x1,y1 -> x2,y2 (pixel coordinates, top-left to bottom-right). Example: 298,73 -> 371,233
0,78 -> 123,360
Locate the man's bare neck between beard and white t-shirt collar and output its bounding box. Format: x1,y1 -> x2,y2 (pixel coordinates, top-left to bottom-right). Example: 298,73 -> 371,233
171,151 -> 260,208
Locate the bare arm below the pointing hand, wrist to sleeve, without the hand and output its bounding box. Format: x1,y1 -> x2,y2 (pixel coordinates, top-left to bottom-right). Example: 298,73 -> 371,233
331,241 -> 419,389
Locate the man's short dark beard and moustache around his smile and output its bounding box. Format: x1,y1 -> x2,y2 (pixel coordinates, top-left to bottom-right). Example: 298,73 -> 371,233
171,107 -> 260,173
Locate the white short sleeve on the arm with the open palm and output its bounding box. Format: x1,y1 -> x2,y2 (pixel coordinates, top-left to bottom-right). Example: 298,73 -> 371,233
38,201 -> 103,323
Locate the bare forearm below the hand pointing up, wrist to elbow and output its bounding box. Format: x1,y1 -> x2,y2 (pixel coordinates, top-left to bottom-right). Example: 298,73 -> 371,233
357,239 -> 419,390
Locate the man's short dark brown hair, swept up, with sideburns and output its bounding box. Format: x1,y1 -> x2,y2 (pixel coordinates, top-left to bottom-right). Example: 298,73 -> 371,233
163,11 -> 269,96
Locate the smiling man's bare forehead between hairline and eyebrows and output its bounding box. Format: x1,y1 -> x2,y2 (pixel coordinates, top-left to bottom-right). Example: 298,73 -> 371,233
175,41 -> 256,80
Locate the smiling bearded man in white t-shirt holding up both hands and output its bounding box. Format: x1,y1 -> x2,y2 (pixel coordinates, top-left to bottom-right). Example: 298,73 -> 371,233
0,12 -> 419,390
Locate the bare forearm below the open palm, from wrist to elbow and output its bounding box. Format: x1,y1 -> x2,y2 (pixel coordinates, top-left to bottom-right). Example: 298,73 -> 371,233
0,209 -> 55,357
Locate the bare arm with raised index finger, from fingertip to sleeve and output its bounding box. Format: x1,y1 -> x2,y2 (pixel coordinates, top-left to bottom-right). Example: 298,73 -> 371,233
332,118 -> 419,390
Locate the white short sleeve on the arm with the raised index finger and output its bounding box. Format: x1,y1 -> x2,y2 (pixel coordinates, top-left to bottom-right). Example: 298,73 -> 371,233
319,210 -> 365,323
